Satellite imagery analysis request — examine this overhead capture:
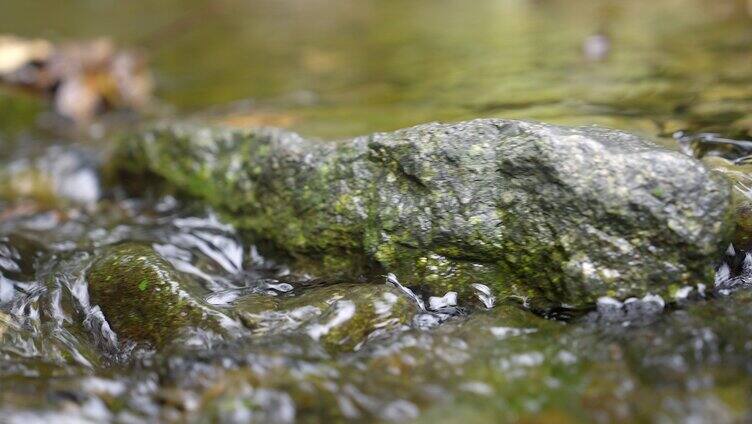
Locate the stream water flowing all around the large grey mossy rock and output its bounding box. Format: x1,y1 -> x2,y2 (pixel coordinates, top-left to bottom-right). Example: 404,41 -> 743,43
0,0 -> 752,424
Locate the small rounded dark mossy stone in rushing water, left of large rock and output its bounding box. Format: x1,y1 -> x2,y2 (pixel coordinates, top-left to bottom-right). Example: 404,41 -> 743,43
87,243 -> 221,348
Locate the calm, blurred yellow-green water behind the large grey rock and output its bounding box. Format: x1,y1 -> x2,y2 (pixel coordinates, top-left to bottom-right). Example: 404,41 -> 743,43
0,0 -> 752,137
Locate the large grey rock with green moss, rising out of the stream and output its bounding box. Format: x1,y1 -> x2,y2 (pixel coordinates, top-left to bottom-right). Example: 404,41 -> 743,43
111,119 -> 733,305
